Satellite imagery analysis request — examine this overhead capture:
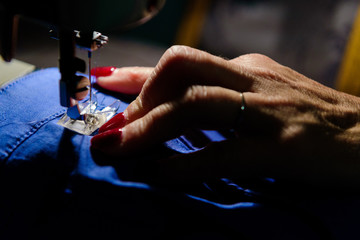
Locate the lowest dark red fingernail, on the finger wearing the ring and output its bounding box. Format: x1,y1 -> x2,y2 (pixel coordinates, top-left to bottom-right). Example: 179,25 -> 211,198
91,129 -> 122,150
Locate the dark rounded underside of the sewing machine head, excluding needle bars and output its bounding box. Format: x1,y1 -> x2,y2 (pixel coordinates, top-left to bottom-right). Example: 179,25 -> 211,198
0,0 -> 165,61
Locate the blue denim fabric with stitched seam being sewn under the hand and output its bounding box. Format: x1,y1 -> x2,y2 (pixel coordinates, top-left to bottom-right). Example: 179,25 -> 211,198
0,68 -> 356,239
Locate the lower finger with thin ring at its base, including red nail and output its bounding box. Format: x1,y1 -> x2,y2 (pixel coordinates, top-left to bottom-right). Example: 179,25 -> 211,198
92,86 -> 253,154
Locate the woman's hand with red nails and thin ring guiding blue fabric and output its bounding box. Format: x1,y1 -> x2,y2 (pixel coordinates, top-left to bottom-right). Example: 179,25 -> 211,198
92,46 -> 360,187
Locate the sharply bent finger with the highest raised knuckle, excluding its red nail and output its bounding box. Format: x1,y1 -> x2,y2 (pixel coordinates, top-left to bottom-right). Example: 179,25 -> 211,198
125,46 -> 253,122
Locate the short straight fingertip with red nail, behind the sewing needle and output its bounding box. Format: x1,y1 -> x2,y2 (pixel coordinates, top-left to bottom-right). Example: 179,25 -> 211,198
91,67 -> 153,94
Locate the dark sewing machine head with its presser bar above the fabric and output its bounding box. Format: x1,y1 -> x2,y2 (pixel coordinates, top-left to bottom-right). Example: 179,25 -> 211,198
0,0 -> 165,107
